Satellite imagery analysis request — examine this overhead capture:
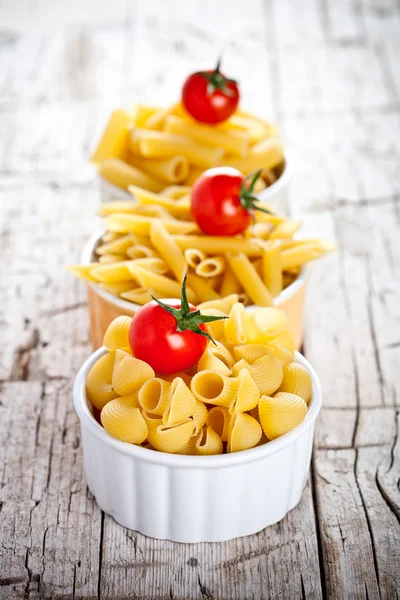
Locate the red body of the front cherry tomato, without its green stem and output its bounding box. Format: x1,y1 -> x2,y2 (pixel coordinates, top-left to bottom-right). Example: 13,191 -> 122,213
129,300 -> 207,374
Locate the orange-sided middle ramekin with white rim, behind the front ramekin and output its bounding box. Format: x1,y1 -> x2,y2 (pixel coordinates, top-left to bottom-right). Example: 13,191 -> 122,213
81,229 -> 308,350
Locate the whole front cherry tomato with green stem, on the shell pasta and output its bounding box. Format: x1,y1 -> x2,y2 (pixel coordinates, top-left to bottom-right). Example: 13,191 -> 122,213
129,276 -> 225,374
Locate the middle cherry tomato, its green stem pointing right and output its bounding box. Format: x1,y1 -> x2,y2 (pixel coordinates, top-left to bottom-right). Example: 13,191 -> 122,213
191,167 -> 269,235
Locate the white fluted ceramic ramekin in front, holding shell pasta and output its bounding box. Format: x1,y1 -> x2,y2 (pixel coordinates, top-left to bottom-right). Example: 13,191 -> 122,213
74,348 -> 322,542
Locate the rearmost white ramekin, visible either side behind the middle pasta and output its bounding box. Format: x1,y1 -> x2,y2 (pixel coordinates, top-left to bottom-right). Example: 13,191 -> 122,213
97,151 -> 293,214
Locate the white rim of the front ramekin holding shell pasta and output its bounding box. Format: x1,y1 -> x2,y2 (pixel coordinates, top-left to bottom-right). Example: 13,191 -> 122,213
73,346 -> 322,469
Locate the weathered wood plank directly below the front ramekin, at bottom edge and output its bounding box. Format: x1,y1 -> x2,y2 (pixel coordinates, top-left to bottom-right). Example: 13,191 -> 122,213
101,485 -> 322,600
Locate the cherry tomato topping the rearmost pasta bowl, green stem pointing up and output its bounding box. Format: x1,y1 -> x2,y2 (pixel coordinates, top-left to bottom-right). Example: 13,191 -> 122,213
182,61 -> 240,124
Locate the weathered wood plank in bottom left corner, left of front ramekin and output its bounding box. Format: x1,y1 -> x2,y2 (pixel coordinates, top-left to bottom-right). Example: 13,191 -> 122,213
0,380 -> 101,600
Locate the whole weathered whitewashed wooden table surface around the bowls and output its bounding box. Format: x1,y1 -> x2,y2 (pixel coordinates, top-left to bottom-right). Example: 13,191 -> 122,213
0,0 -> 400,600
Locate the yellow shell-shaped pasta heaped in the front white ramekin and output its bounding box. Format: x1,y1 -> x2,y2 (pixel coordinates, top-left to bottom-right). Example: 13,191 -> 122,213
86,298 -> 312,455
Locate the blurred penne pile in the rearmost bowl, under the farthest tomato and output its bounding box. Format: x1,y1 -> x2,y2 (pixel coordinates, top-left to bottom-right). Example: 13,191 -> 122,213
91,103 -> 284,192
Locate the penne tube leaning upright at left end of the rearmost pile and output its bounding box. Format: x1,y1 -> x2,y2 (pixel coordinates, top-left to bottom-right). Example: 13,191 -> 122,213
90,110 -> 130,163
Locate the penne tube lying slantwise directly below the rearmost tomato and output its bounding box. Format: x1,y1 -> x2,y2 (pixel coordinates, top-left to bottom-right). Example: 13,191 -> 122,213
165,115 -> 249,156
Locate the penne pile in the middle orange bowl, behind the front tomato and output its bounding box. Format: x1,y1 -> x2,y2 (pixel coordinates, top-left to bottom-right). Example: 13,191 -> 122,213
69,186 -> 333,306
